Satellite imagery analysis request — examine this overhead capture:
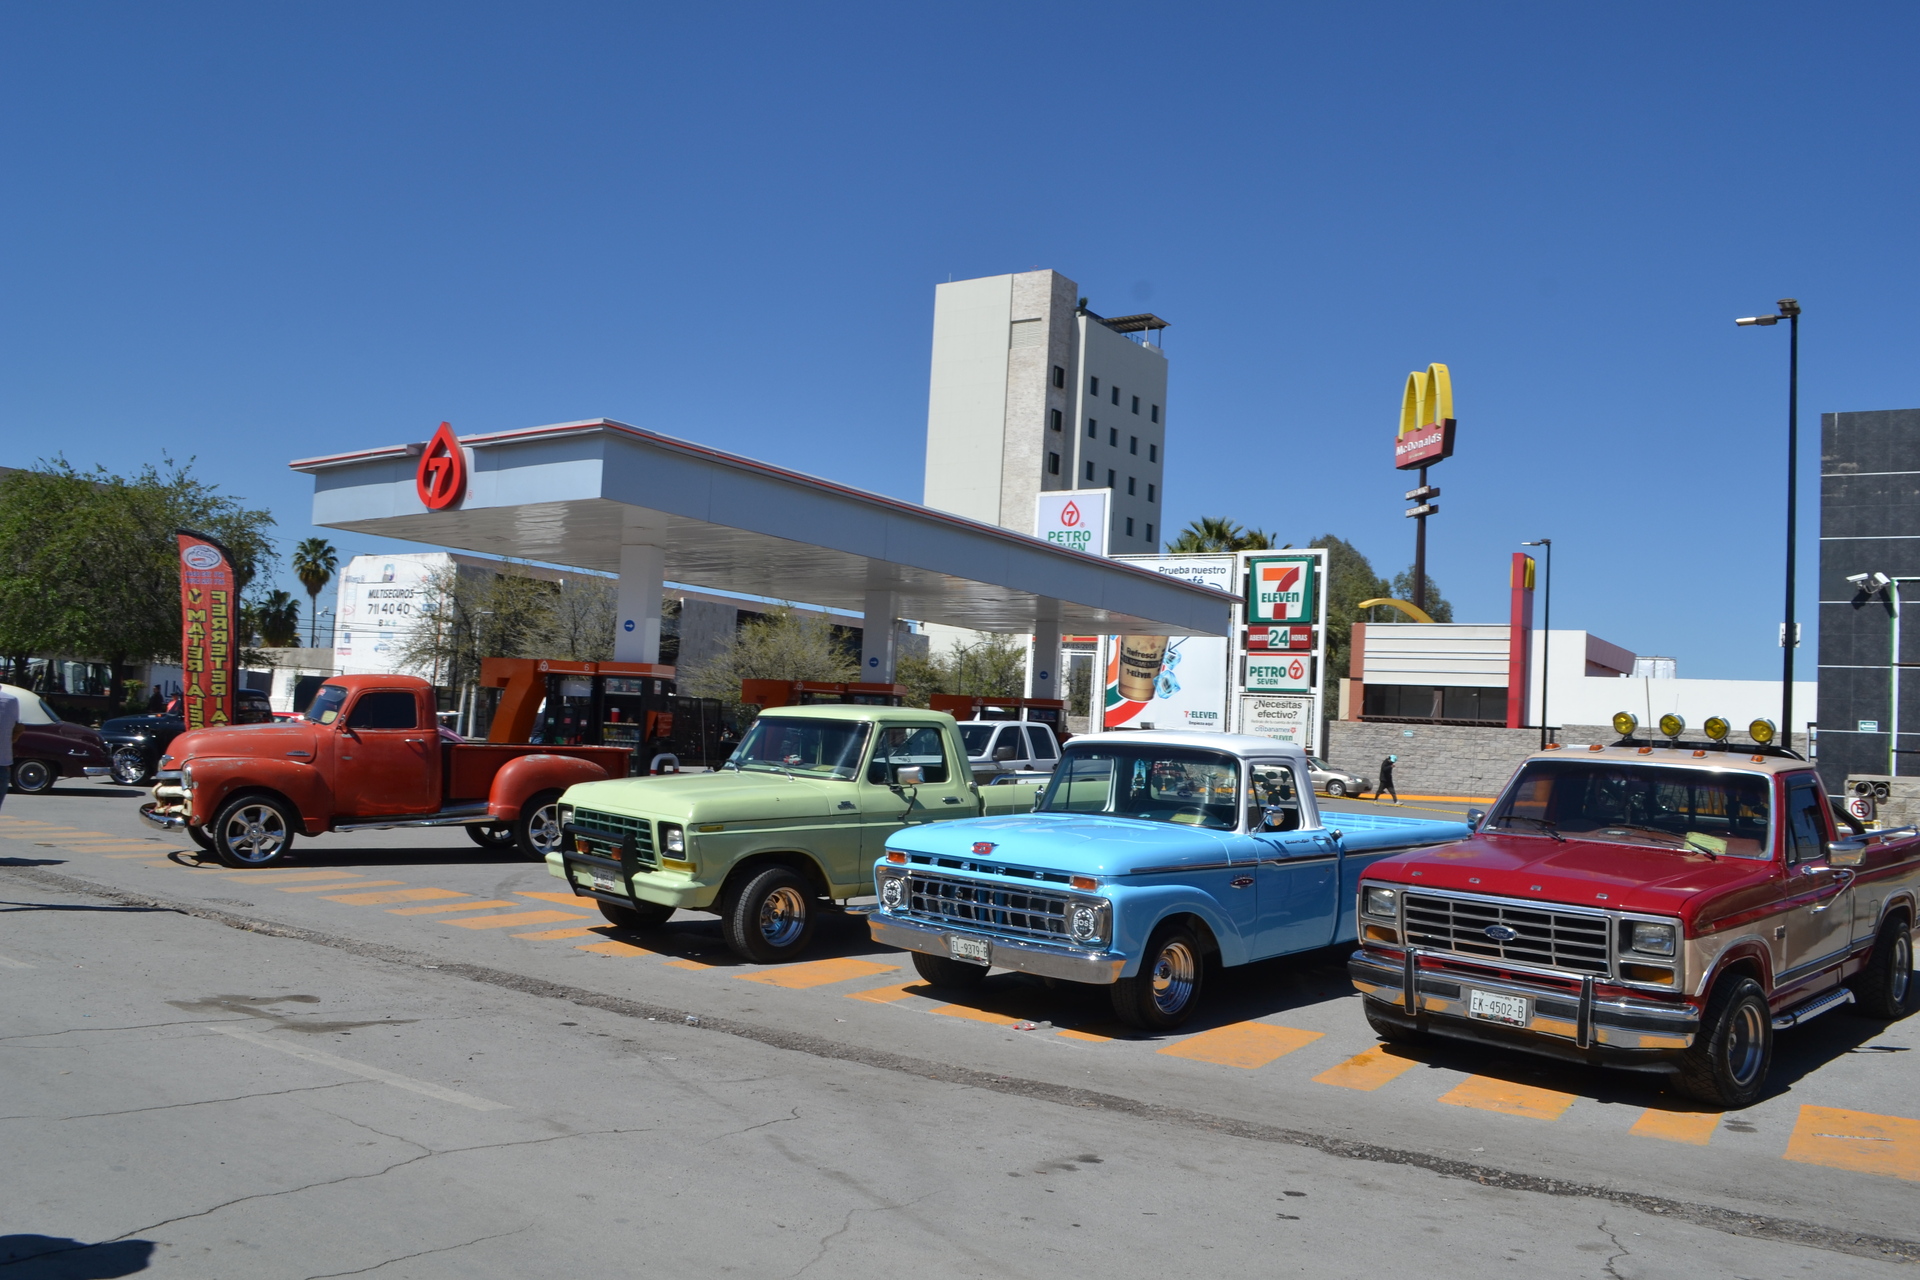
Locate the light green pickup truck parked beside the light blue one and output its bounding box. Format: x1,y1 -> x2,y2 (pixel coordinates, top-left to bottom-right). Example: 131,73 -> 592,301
547,706 -> 1039,963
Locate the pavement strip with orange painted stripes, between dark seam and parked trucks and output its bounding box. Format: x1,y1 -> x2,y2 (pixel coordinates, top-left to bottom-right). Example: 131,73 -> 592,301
0,787 -> 1920,1274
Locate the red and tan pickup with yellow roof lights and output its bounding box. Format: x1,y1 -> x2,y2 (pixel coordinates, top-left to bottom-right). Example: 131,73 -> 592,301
1348,743 -> 1920,1107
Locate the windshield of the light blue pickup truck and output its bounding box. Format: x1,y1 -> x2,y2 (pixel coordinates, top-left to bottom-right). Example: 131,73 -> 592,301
1035,743 -> 1240,831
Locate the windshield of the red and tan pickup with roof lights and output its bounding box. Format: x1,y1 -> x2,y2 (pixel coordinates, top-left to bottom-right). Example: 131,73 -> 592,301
1486,760 -> 1770,858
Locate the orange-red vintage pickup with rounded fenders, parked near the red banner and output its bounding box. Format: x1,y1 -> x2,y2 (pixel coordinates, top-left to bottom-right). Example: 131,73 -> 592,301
140,676 -> 628,867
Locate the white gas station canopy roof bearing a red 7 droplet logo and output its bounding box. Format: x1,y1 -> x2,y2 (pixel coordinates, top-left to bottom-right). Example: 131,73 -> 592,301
292,418 -> 1233,640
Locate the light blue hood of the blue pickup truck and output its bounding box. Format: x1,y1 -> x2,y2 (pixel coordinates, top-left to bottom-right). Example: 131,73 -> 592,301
887,814 -> 1238,877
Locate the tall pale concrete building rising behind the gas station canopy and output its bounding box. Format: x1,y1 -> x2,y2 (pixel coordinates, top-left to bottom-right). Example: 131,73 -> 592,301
924,271 -> 1167,555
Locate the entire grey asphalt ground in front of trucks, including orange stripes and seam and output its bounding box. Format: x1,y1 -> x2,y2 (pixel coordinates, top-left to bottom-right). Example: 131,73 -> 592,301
0,783 -> 1920,1280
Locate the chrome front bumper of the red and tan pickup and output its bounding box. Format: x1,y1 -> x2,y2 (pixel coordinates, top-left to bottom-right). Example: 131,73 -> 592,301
1346,952 -> 1699,1063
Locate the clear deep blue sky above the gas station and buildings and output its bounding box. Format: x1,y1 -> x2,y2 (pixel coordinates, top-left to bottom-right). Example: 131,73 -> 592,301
0,4 -> 1920,677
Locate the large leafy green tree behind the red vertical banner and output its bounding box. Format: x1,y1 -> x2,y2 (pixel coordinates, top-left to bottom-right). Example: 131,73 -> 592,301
0,457 -> 275,702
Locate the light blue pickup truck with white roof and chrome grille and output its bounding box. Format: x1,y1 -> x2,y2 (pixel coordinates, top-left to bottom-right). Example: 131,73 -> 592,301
870,731 -> 1469,1031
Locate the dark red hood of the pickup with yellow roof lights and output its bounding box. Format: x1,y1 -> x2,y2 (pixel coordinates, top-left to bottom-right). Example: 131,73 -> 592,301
1367,833 -> 1774,921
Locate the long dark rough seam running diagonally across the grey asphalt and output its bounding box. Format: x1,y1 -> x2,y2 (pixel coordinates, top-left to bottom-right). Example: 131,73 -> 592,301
15,867 -> 1920,1263
